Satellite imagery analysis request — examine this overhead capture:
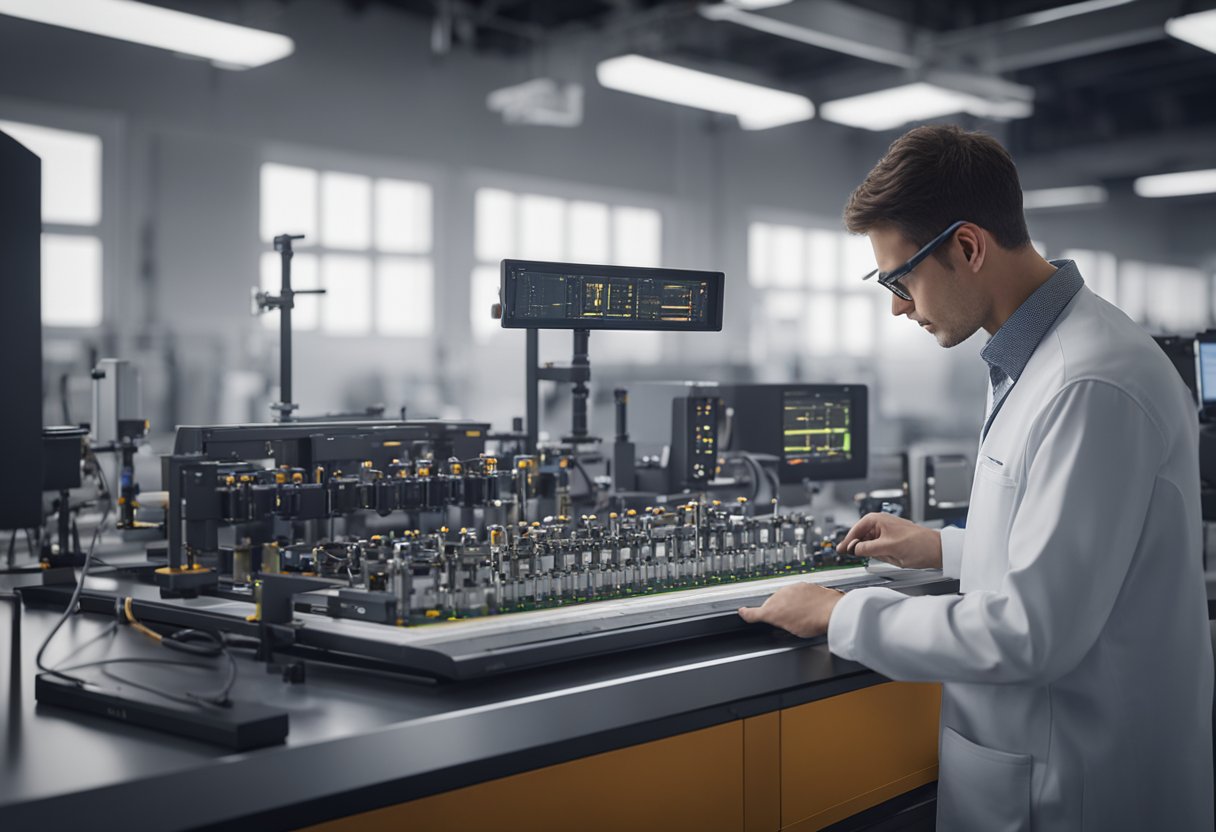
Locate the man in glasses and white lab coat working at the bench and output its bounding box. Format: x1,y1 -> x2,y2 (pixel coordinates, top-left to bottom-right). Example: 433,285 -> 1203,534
739,127 -> 1212,832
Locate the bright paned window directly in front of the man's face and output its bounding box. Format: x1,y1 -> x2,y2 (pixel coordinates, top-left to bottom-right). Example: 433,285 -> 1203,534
748,223 -> 880,362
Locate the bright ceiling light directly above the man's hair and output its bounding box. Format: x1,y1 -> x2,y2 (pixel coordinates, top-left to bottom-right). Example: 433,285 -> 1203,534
820,81 -> 1034,130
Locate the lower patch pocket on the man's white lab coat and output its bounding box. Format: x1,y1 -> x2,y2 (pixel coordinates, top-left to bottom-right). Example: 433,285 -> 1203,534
938,727 -> 1034,832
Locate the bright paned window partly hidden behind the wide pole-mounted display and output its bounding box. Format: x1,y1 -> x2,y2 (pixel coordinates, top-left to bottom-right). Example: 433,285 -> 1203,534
469,187 -> 663,361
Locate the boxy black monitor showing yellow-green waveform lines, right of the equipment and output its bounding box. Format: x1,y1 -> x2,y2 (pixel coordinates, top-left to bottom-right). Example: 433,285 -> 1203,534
721,384 -> 869,483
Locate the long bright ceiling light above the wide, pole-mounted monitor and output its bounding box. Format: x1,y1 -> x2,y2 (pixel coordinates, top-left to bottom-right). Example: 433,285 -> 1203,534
596,55 -> 815,130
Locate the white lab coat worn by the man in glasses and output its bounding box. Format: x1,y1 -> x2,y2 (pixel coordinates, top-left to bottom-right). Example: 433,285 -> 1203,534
828,288 -> 1212,832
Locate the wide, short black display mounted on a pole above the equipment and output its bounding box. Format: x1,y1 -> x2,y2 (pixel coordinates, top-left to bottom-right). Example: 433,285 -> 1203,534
500,260 -> 725,332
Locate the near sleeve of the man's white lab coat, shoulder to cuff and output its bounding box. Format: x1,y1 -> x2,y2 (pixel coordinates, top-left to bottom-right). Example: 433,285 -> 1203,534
828,380 -> 1166,684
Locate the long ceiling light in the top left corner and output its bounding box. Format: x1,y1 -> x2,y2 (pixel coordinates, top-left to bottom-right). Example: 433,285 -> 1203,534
0,0 -> 295,69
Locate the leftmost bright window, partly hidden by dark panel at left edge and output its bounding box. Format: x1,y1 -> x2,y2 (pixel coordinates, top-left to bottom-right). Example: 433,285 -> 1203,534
0,122 -> 102,327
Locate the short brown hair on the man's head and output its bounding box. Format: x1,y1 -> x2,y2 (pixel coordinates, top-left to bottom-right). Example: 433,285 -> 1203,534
844,124 -> 1030,248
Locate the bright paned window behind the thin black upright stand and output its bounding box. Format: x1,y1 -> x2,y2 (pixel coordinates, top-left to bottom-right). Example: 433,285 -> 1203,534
260,163 -> 434,337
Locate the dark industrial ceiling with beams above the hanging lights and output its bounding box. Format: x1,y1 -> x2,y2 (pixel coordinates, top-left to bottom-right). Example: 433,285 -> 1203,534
336,0 -> 1216,164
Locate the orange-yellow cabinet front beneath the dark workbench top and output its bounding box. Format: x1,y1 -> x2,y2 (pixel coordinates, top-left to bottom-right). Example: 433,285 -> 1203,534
296,682 -> 941,832
